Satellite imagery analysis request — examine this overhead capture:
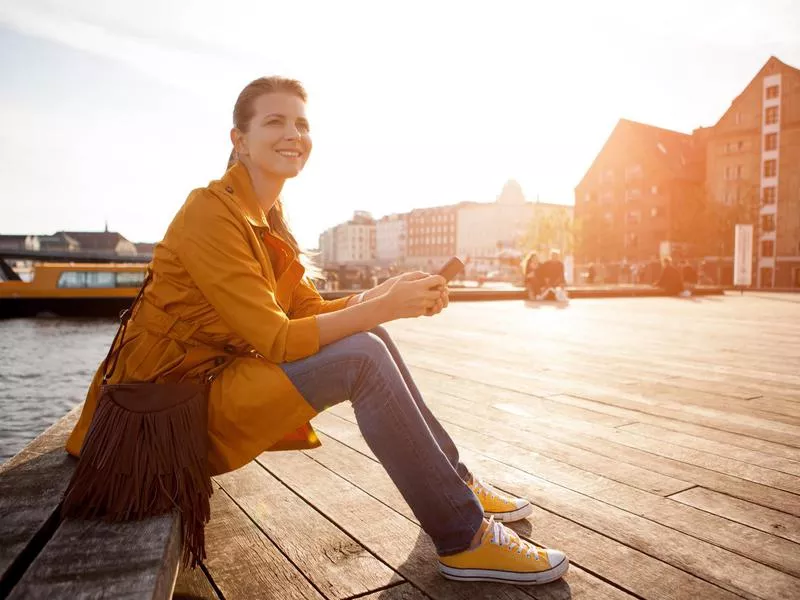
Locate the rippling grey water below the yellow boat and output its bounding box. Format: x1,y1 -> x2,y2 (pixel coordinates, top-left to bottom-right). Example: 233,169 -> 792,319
0,319 -> 117,463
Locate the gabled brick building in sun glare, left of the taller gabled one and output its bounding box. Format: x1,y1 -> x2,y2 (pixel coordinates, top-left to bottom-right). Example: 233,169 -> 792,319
575,119 -> 705,264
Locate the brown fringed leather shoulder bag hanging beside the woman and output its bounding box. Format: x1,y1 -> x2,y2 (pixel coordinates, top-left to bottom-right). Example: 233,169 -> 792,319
61,275 -> 235,568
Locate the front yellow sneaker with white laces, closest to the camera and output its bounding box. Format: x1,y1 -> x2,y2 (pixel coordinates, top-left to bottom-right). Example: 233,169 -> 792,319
439,519 -> 569,585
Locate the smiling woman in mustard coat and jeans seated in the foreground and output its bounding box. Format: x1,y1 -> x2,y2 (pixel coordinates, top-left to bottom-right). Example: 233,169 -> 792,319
67,77 -> 568,584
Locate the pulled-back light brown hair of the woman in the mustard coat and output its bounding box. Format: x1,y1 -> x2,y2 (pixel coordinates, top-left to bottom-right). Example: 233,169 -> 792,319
228,76 -> 322,277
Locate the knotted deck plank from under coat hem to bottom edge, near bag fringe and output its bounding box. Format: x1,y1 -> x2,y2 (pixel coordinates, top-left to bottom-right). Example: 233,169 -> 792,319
216,463 -> 403,600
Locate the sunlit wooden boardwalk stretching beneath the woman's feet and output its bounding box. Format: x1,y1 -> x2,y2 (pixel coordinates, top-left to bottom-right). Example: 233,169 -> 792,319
175,294 -> 800,600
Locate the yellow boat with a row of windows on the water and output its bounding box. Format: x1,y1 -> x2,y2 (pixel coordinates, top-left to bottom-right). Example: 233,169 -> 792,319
0,263 -> 147,319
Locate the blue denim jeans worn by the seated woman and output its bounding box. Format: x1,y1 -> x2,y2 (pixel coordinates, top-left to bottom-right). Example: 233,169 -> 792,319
281,327 -> 483,555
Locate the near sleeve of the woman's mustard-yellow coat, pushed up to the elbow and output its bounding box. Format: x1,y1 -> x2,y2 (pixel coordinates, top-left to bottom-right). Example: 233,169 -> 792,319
177,190 -> 319,363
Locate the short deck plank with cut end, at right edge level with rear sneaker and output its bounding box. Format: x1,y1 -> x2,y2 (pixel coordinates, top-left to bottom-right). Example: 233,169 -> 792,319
670,487 -> 800,544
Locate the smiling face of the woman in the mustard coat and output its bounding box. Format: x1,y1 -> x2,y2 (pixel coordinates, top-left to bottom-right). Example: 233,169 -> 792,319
231,92 -> 311,179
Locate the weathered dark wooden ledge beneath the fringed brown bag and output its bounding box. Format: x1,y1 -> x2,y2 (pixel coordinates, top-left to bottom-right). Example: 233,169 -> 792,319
0,407 -> 188,600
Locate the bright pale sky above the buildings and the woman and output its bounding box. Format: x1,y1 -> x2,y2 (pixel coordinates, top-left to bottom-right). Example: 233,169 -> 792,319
0,0 -> 800,248
